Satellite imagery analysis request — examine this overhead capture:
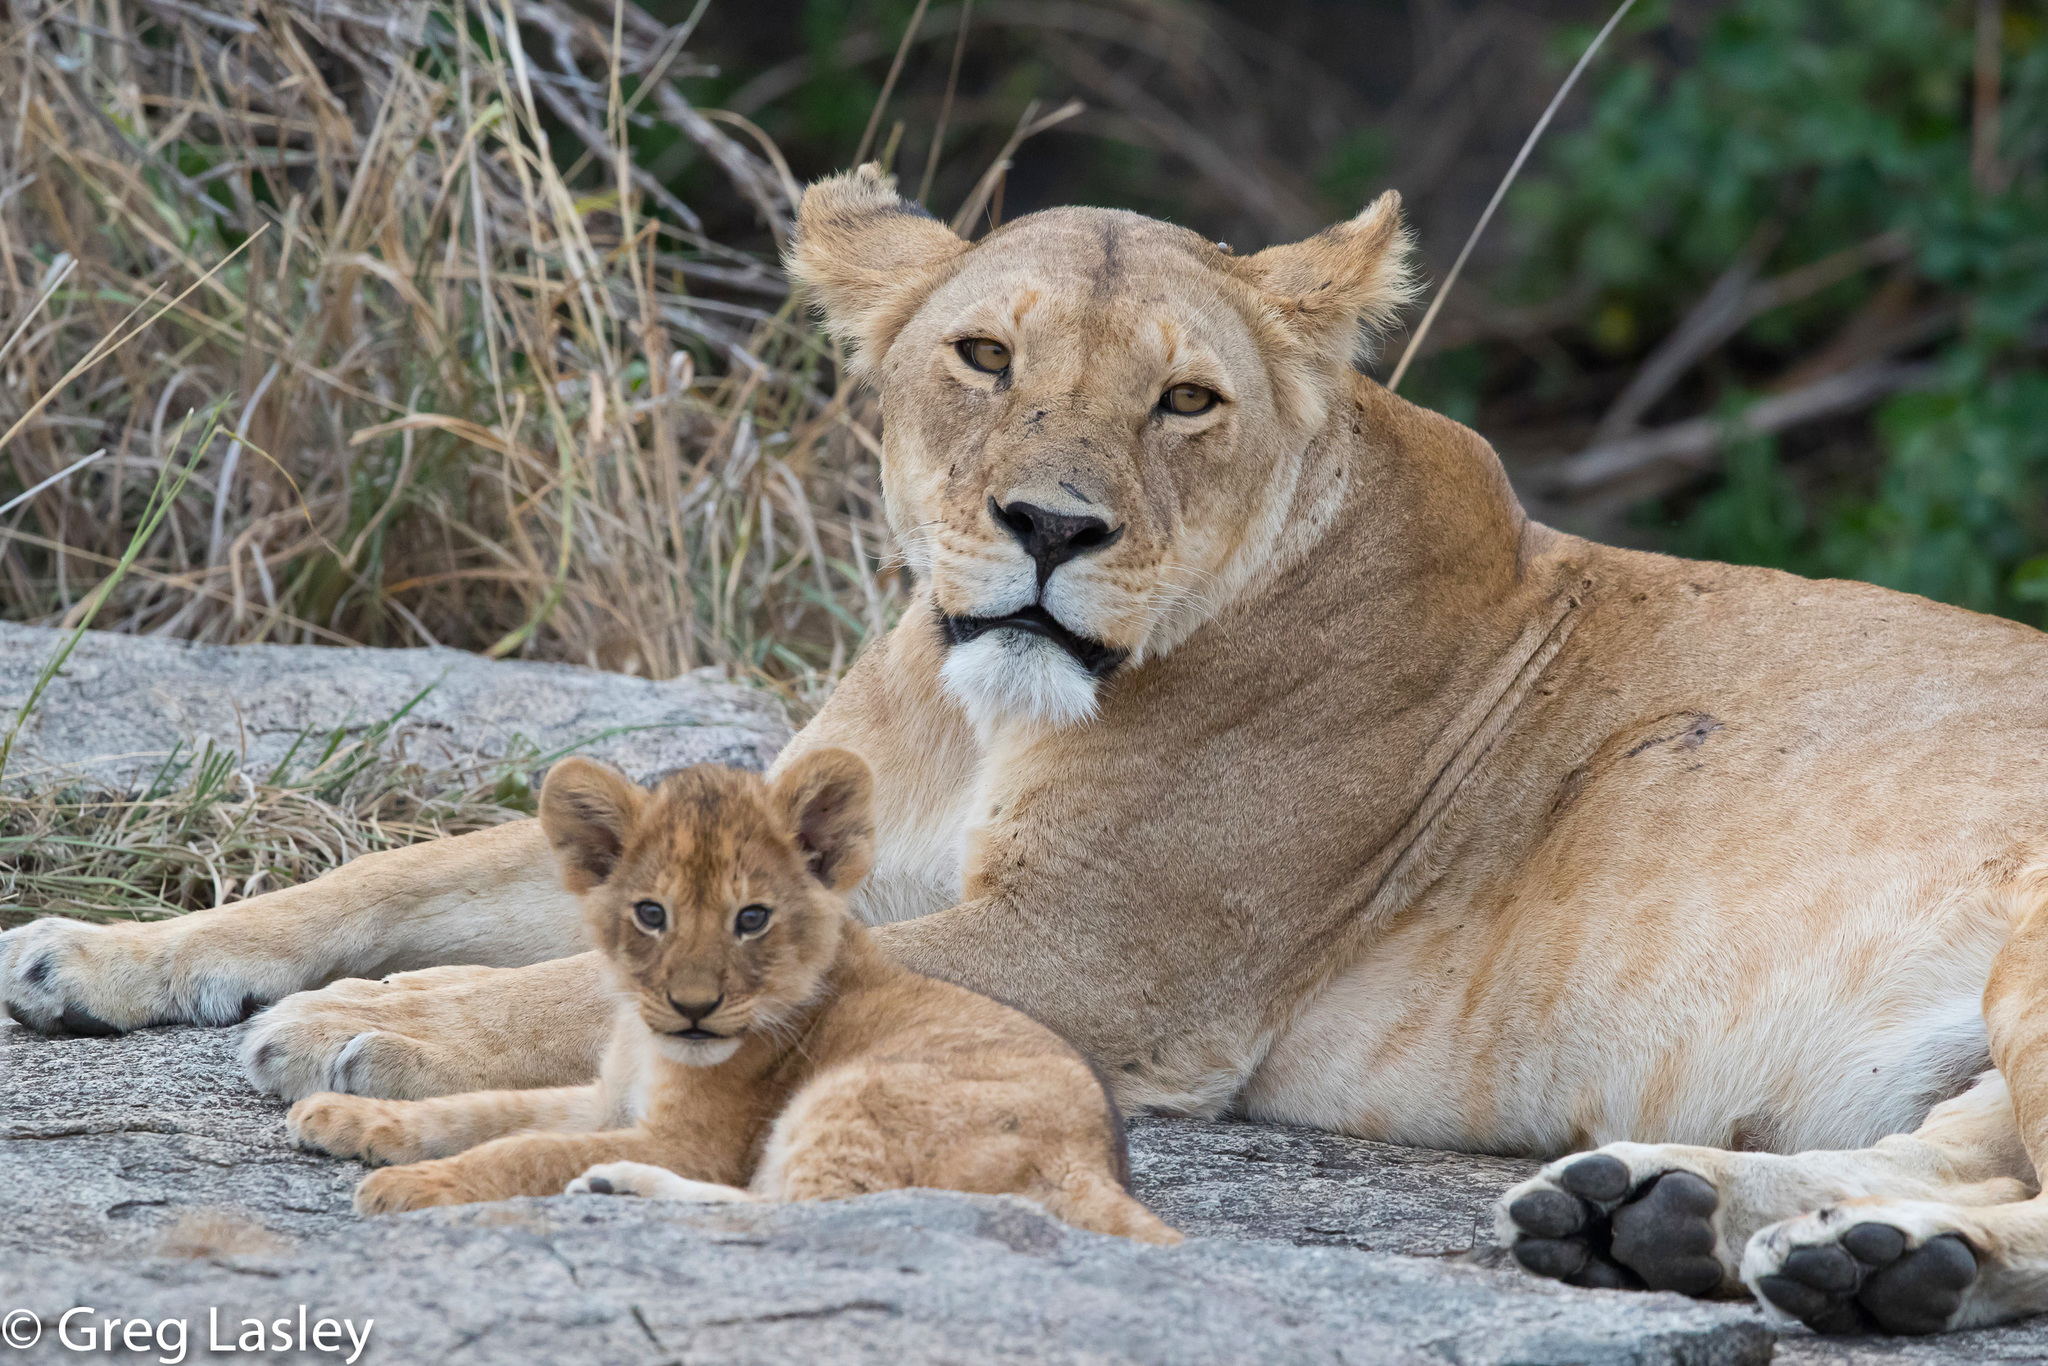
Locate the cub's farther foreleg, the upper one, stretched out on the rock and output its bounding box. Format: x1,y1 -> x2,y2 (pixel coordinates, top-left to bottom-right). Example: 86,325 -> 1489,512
285,1085 -> 610,1167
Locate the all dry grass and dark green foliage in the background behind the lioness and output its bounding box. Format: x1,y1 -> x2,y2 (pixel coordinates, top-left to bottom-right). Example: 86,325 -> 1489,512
0,0 -> 2048,671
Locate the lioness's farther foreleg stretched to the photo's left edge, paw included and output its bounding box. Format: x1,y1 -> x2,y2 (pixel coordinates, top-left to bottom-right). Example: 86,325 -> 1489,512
0,821 -> 586,1034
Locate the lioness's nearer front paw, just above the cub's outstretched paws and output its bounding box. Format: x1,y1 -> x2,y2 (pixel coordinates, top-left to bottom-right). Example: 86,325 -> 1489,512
242,975 -> 489,1100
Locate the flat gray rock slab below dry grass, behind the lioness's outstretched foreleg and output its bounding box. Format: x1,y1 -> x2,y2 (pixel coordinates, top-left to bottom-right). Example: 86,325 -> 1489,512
0,623 -> 788,791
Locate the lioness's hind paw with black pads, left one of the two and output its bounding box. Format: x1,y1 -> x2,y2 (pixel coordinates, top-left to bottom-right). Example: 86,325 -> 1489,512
1495,1143 -> 1739,1296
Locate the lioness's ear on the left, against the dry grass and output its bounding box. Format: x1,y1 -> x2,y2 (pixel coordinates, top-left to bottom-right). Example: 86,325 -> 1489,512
784,162 -> 967,375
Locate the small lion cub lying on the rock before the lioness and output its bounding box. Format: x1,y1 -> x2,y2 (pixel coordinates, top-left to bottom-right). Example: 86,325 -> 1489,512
287,750 -> 1180,1243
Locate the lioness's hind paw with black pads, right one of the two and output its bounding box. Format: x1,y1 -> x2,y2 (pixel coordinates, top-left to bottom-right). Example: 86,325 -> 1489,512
1743,1202 -> 1980,1333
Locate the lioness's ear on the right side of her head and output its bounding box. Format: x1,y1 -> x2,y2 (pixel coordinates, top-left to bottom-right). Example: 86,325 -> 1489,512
1245,190 -> 1415,360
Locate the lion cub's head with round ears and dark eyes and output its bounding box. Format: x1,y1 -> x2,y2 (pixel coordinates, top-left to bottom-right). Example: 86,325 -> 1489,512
541,750 -> 872,1067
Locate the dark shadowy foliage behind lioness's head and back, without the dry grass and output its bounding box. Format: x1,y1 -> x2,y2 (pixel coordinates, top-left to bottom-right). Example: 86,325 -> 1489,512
678,0 -> 2048,625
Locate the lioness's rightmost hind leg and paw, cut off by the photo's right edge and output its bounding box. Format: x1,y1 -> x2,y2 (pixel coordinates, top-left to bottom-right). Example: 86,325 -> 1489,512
1743,905 -> 2048,1333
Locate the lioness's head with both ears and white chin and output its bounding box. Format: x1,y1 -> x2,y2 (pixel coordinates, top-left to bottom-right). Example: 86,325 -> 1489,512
791,168 -> 1403,725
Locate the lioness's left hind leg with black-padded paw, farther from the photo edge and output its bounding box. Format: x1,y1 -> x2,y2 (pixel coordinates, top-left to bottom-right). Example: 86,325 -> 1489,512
1495,1073 -> 2034,1296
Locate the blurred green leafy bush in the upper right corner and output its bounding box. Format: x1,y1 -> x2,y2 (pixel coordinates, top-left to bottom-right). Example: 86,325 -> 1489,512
1509,0 -> 2048,625
